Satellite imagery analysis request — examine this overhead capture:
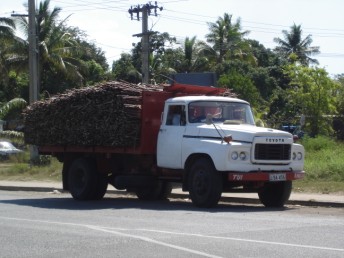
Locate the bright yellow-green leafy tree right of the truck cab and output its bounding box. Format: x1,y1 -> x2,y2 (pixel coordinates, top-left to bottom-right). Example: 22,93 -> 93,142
285,65 -> 337,136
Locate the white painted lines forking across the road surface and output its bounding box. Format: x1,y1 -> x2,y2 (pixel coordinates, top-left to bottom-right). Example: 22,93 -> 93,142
0,217 -> 344,254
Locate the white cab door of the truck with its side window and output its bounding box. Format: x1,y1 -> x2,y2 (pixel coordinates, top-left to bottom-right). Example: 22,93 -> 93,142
157,104 -> 186,169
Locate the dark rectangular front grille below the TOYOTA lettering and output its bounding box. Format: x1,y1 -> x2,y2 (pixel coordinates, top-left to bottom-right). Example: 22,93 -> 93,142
254,143 -> 291,160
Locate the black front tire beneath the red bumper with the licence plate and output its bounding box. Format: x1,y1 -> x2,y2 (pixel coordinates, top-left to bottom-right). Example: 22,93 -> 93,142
258,181 -> 292,208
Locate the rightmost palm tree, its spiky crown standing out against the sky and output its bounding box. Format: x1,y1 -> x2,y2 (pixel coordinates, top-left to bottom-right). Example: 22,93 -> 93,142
274,24 -> 320,66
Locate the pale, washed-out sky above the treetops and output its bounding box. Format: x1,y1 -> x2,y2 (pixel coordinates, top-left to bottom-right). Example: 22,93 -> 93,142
0,0 -> 344,76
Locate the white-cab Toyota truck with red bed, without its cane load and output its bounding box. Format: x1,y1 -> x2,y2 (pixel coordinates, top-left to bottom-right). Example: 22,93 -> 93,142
33,83 -> 305,208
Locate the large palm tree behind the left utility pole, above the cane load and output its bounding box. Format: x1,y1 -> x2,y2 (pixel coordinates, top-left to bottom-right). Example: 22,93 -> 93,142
13,0 -> 82,90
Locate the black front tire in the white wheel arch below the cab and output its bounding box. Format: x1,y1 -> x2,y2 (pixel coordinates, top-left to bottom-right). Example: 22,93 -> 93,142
189,158 -> 223,208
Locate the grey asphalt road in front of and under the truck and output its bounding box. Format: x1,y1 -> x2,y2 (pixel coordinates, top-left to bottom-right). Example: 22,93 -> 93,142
0,191 -> 344,258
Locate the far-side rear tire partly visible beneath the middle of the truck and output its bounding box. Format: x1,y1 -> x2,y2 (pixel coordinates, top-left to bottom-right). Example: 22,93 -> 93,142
135,181 -> 172,201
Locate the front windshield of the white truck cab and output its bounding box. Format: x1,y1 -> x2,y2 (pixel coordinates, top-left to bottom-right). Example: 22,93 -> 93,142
188,101 -> 255,125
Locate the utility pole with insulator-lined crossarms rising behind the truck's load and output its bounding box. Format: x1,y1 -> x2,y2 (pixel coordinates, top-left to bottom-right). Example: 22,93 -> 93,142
128,2 -> 162,84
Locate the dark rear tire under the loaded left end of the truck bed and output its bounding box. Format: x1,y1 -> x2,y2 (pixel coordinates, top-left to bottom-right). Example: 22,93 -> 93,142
68,158 -> 107,201
